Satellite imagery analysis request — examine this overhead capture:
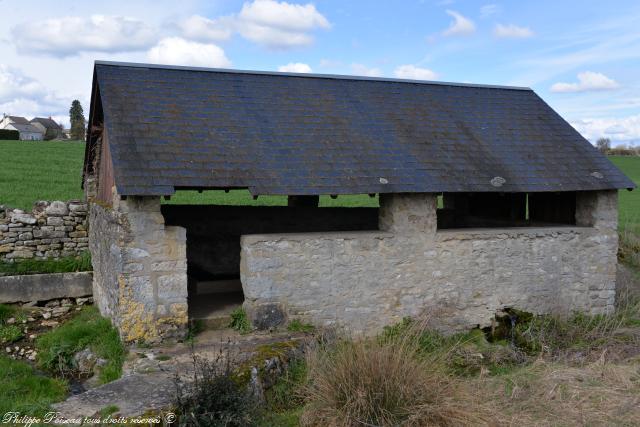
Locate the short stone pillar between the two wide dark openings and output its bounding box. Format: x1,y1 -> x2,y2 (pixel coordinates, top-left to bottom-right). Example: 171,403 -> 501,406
378,193 -> 438,235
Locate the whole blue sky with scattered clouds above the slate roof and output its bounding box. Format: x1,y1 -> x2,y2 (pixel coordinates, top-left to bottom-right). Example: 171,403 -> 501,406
0,0 -> 640,145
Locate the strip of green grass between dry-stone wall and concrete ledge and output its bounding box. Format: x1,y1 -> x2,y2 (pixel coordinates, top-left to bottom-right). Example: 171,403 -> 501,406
0,251 -> 92,276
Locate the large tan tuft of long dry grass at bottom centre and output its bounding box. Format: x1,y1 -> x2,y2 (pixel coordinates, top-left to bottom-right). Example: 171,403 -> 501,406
302,326 -> 490,426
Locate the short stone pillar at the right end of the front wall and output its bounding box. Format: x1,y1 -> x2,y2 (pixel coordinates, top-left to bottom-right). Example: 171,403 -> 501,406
576,190 -> 618,230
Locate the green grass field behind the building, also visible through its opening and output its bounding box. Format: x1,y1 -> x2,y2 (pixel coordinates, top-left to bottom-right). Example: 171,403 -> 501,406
0,141 -> 640,228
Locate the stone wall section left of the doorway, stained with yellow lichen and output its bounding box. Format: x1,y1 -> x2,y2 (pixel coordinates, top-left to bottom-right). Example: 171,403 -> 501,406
89,197 -> 188,342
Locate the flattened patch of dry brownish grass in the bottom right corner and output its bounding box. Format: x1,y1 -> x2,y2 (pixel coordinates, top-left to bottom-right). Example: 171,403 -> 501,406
477,358 -> 640,426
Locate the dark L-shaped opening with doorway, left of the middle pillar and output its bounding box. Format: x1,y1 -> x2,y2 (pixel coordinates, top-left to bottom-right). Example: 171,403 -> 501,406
161,206 -> 378,327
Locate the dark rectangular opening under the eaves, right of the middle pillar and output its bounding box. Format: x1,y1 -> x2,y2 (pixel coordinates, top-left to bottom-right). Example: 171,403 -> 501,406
438,192 -> 576,229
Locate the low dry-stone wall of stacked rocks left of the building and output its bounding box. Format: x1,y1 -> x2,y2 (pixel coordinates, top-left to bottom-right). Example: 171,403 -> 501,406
0,200 -> 89,261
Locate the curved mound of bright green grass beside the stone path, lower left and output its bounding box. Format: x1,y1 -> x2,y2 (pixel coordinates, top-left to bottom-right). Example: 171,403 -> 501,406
36,306 -> 125,383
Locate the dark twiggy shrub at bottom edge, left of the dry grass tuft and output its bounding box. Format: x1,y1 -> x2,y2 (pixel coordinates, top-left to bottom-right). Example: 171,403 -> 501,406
175,351 -> 258,427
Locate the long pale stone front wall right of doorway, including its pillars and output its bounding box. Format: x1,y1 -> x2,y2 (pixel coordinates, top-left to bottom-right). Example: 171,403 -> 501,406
241,191 -> 618,334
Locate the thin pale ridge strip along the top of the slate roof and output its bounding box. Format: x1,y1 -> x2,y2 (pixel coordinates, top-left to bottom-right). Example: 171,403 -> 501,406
94,60 -> 533,91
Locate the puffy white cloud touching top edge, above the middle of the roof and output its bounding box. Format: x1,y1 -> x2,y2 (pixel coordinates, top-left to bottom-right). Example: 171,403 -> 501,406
236,0 -> 331,49
